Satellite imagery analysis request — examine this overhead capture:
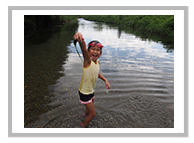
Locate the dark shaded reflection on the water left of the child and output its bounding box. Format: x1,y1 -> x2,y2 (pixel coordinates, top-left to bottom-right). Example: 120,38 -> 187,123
24,21 -> 77,125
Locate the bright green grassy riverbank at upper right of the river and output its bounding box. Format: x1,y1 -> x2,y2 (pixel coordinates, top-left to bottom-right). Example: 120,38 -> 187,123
81,15 -> 174,36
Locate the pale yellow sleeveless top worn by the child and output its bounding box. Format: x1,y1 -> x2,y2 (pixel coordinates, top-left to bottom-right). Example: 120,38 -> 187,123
79,61 -> 100,95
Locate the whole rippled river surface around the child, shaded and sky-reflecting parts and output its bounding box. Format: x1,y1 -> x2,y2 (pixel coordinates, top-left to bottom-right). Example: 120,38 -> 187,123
24,19 -> 174,128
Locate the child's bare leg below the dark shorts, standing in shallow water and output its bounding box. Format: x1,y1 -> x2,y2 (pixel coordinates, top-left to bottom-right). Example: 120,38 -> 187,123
84,102 -> 96,125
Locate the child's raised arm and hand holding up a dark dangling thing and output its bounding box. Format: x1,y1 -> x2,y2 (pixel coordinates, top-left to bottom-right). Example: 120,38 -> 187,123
73,32 -> 91,68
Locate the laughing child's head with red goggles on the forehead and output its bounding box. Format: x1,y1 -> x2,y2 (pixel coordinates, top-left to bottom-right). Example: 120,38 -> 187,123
88,40 -> 103,61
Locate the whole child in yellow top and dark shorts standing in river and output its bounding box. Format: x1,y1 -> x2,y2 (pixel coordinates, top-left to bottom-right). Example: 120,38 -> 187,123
73,32 -> 110,128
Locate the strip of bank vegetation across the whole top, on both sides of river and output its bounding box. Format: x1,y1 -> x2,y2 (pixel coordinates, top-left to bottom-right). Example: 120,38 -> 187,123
24,15 -> 174,36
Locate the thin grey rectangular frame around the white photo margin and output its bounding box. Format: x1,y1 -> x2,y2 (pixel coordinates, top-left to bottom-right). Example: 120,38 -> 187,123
8,6 -> 188,137
